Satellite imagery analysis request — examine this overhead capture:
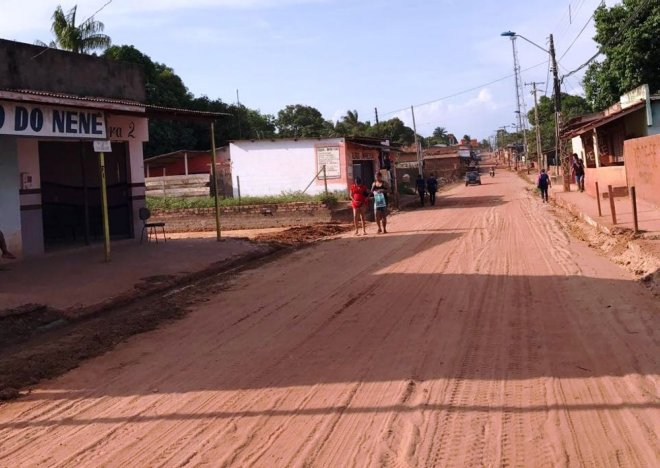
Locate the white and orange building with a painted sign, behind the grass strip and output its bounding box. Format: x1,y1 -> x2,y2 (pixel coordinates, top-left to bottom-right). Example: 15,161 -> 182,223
229,137 -> 398,196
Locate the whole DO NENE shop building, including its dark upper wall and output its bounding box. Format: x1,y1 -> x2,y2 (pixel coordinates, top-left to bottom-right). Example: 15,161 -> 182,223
0,40 -> 223,256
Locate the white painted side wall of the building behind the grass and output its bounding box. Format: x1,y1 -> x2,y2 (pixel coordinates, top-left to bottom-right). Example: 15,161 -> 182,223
229,138 -> 346,196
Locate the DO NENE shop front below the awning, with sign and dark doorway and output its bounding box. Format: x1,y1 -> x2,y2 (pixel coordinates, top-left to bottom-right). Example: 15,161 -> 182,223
0,91 -> 148,257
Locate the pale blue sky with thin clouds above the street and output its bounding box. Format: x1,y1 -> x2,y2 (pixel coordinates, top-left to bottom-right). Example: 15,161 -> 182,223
0,0 -> 614,139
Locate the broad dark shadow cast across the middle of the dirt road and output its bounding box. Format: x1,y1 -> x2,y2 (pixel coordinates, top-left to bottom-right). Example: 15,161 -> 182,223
0,225 -> 660,414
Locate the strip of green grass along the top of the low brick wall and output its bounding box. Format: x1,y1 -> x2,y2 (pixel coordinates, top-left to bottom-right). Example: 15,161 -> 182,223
147,191 -> 348,210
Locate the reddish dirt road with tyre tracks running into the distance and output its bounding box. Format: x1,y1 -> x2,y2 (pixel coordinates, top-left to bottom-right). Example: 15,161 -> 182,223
0,171 -> 660,467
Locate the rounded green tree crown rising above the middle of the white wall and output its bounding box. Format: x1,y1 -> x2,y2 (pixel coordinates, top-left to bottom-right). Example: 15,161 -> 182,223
275,104 -> 334,138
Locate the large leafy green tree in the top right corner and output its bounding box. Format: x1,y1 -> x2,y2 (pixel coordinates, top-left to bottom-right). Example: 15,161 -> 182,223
583,0 -> 660,110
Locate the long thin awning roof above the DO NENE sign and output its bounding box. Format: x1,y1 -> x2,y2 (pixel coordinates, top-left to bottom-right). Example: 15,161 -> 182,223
0,89 -> 231,122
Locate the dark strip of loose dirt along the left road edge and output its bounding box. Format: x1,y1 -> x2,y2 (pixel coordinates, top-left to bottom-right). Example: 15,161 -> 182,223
0,248 -> 283,402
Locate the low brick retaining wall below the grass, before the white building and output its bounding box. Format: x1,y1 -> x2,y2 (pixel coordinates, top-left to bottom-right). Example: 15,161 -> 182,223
150,202 -> 352,232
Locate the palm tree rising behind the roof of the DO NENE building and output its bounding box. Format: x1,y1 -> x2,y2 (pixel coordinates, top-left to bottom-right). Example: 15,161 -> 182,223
36,5 -> 111,54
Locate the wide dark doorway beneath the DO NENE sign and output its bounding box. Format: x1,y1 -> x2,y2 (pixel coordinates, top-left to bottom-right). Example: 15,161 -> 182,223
39,141 -> 132,250
